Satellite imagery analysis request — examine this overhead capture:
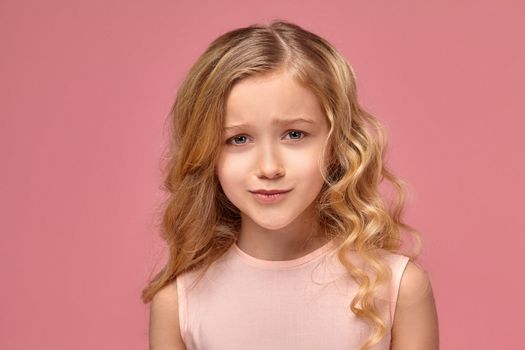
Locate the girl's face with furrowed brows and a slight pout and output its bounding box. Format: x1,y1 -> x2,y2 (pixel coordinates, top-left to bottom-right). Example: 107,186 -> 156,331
217,72 -> 329,230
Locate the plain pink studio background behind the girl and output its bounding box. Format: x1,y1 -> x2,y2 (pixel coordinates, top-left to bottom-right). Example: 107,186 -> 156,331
0,0 -> 525,350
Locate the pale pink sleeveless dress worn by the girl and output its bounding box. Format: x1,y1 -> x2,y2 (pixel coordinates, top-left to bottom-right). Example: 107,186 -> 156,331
177,241 -> 409,350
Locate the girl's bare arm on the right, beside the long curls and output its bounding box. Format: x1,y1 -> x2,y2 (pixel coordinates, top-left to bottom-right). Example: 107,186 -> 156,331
390,261 -> 439,350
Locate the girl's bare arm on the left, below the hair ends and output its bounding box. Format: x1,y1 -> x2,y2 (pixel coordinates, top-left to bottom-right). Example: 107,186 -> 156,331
149,281 -> 186,350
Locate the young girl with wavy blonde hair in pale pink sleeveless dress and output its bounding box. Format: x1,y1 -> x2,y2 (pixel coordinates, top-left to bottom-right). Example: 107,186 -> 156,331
142,21 -> 438,350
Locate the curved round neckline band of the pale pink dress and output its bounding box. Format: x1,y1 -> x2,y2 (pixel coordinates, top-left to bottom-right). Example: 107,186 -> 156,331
233,239 -> 335,269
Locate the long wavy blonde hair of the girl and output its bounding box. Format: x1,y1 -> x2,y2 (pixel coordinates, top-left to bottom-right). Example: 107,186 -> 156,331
142,20 -> 421,350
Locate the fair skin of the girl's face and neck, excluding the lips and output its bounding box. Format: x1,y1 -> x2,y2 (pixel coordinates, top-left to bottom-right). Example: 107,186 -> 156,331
217,71 -> 329,260
